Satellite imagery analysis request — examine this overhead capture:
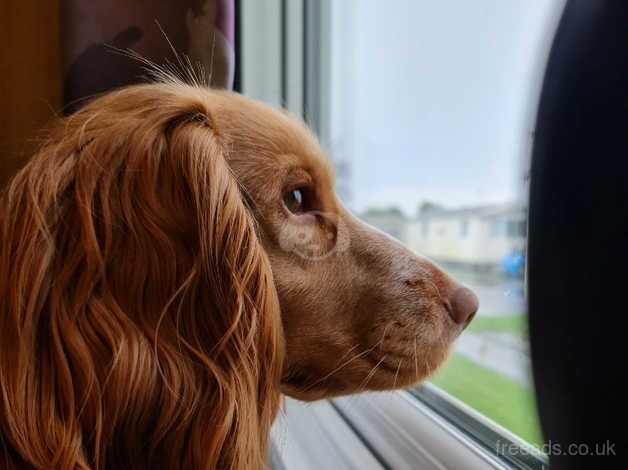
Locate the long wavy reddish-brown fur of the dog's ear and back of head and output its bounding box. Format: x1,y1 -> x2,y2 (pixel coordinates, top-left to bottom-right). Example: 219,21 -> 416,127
0,84 -> 283,469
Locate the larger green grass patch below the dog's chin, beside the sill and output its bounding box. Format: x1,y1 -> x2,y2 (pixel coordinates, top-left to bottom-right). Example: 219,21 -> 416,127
432,354 -> 543,445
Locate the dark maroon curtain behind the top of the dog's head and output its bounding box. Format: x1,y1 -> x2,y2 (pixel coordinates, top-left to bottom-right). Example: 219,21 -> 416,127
61,0 -> 235,113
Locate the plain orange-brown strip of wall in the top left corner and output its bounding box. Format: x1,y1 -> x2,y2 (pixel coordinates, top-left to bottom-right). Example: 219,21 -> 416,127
0,0 -> 61,187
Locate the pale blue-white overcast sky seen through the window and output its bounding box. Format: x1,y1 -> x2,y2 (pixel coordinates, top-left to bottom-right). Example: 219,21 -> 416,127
330,0 -> 564,215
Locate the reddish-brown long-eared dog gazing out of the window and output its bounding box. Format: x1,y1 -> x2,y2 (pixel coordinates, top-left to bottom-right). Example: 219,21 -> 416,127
0,81 -> 478,469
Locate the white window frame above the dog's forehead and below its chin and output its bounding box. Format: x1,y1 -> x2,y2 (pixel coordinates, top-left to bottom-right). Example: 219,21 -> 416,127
237,0 -> 558,470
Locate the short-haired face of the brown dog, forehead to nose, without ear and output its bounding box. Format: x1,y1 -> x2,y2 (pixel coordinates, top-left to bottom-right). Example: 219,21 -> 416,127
210,93 -> 478,400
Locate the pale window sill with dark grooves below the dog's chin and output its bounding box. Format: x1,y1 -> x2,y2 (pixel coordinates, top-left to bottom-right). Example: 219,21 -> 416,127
272,385 -> 547,470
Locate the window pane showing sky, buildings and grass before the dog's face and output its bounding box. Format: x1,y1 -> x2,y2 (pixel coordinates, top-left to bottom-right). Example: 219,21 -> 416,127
327,0 -> 564,443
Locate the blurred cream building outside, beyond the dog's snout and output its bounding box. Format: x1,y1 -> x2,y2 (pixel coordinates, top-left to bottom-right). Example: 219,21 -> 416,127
362,204 -> 527,271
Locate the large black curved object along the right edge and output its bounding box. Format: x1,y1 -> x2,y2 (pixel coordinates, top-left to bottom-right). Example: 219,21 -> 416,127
528,0 -> 628,469
